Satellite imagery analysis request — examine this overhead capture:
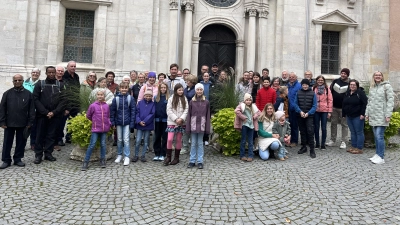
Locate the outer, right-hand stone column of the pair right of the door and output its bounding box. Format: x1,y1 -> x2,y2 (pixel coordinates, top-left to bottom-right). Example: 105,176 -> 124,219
254,9 -> 270,72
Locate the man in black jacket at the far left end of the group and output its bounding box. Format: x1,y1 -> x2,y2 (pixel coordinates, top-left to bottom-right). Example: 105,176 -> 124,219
0,74 -> 35,169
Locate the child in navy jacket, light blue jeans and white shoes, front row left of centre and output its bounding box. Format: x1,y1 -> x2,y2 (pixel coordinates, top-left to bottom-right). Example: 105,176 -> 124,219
111,82 -> 136,166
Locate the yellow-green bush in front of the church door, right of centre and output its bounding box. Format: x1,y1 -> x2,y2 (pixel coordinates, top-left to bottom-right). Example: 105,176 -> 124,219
211,108 -> 241,156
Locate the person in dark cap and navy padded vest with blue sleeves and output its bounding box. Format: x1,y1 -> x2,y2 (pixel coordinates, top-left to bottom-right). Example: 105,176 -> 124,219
293,79 -> 317,158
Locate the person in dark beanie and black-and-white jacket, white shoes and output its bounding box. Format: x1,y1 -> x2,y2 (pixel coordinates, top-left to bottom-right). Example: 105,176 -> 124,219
326,68 -> 350,149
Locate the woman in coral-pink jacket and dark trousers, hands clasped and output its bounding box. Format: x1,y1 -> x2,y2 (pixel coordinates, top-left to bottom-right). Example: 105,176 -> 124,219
313,75 -> 333,150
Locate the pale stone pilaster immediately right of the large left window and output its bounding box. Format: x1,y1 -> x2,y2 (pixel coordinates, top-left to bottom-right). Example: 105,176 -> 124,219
92,4 -> 107,67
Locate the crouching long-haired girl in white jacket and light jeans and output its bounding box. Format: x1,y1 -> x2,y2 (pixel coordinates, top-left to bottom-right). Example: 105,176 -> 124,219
258,103 -> 284,160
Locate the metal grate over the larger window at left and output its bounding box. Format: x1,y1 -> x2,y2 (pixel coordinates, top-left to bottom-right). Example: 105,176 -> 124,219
63,9 -> 94,63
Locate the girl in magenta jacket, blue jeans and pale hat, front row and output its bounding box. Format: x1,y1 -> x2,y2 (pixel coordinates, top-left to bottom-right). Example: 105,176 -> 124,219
82,90 -> 111,171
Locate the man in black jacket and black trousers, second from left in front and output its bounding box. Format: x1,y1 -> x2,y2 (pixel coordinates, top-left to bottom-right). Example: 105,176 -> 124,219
33,66 -> 65,164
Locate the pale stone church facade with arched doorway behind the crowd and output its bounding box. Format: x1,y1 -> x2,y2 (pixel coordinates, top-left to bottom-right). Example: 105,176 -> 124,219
0,0 -> 400,94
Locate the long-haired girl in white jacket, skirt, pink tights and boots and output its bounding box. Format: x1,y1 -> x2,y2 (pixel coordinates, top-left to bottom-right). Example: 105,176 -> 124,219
164,83 -> 189,166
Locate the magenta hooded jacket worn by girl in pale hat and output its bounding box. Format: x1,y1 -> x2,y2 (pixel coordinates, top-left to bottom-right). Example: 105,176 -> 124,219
86,101 -> 111,133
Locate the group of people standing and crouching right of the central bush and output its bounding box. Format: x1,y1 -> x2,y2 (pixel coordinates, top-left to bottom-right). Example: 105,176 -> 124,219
234,68 -> 394,164
